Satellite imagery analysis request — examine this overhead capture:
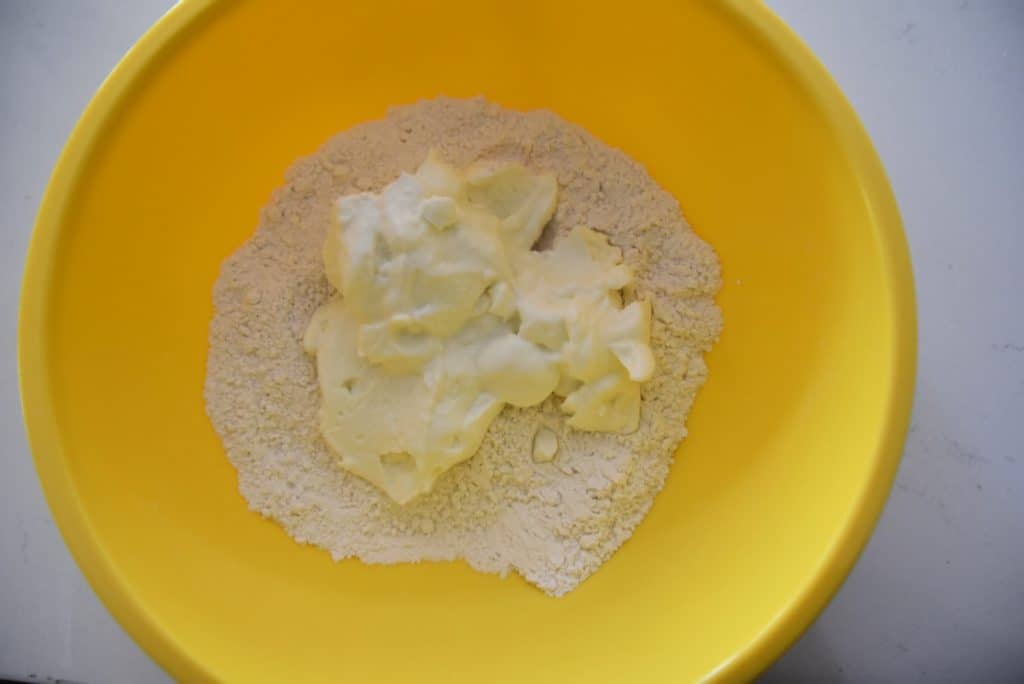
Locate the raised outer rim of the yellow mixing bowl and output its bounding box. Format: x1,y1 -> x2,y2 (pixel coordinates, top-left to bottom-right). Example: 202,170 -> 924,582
17,0 -> 918,682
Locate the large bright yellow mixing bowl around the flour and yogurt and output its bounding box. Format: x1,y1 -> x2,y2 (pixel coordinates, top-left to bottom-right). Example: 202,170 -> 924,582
19,0 -> 915,684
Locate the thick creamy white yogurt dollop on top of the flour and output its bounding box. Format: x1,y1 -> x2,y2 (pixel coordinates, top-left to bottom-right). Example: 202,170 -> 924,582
305,154 -> 654,503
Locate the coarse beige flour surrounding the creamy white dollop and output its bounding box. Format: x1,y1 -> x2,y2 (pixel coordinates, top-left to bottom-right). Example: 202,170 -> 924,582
205,98 -> 722,596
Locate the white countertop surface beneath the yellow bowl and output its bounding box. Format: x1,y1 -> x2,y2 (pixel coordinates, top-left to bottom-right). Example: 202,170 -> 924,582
0,0 -> 1024,684
